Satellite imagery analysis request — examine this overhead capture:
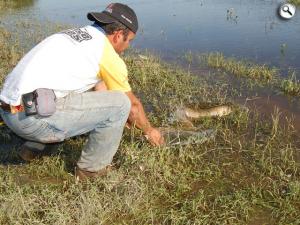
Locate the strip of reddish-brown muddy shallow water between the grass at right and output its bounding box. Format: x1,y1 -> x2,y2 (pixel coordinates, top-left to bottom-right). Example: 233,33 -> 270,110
190,64 -> 300,133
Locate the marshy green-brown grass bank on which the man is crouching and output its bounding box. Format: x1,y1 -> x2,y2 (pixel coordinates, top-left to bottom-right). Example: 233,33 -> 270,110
0,25 -> 300,225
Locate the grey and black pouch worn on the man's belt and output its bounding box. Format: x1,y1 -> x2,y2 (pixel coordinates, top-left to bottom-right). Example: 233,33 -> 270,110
22,88 -> 56,117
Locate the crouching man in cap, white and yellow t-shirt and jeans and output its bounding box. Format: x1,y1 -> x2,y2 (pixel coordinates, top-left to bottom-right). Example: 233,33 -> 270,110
0,3 -> 164,180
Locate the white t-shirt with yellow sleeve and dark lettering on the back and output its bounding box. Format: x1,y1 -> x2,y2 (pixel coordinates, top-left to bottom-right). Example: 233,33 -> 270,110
0,25 -> 130,105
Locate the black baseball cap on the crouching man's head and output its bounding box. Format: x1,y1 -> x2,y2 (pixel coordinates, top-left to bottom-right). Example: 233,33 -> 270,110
87,3 -> 138,33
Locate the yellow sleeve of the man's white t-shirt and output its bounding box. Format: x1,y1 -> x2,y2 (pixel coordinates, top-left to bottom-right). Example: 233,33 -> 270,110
98,38 -> 131,92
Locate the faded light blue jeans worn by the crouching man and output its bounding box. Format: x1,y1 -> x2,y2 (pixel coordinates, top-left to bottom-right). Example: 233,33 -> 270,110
0,91 -> 131,172
